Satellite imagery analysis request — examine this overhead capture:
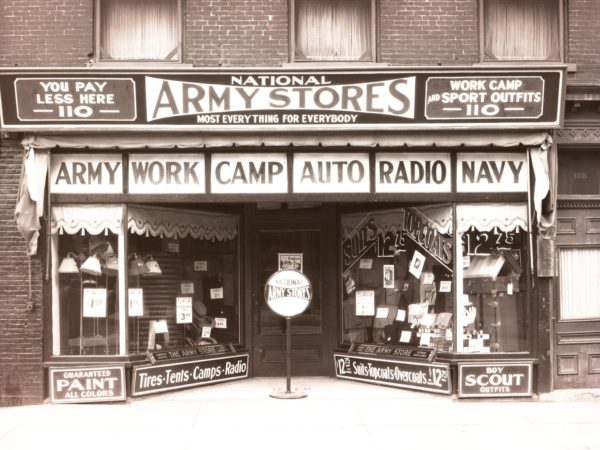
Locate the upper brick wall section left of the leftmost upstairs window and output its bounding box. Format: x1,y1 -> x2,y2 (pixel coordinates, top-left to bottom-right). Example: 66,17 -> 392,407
0,0 -> 94,67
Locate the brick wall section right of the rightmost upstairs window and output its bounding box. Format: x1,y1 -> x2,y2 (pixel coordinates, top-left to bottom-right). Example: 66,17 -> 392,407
567,0 -> 600,85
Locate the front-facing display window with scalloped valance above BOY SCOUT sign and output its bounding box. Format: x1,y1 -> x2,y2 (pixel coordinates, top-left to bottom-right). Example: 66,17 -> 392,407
456,204 -> 529,353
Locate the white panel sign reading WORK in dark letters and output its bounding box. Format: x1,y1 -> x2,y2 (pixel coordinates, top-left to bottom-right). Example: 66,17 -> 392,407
129,153 -> 206,194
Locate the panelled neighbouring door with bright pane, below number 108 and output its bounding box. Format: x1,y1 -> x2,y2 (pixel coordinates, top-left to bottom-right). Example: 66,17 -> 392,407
554,205 -> 600,389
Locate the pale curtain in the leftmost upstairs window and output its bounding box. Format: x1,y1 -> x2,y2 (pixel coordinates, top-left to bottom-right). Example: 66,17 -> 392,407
100,0 -> 179,61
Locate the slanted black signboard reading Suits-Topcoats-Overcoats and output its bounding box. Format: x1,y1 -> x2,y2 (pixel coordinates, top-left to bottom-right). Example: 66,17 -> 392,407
333,354 -> 450,394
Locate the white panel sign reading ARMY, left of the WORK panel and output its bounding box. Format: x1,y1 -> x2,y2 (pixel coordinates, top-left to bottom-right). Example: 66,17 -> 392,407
50,153 -> 123,194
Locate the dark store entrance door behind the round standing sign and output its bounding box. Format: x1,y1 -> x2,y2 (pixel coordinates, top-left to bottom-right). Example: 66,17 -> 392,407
246,206 -> 337,376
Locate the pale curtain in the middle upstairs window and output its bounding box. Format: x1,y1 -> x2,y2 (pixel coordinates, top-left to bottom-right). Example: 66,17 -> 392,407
295,0 -> 373,61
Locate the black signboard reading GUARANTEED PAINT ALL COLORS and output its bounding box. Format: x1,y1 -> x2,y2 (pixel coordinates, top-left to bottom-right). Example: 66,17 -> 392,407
49,366 -> 127,403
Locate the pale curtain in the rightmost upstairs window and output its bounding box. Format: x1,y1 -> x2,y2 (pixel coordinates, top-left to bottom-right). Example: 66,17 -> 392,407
484,0 -> 560,60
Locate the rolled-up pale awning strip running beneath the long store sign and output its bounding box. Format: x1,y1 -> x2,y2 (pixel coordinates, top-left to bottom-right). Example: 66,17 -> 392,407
22,131 -> 548,150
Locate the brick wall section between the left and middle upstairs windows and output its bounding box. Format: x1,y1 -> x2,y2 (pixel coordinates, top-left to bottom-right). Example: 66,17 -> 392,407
184,0 -> 289,66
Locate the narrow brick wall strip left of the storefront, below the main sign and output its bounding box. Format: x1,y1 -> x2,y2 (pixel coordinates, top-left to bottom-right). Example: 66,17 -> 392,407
0,139 -> 44,406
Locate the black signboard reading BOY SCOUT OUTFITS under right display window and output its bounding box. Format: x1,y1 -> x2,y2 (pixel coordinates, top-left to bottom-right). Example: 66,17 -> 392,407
458,362 -> 533,397
